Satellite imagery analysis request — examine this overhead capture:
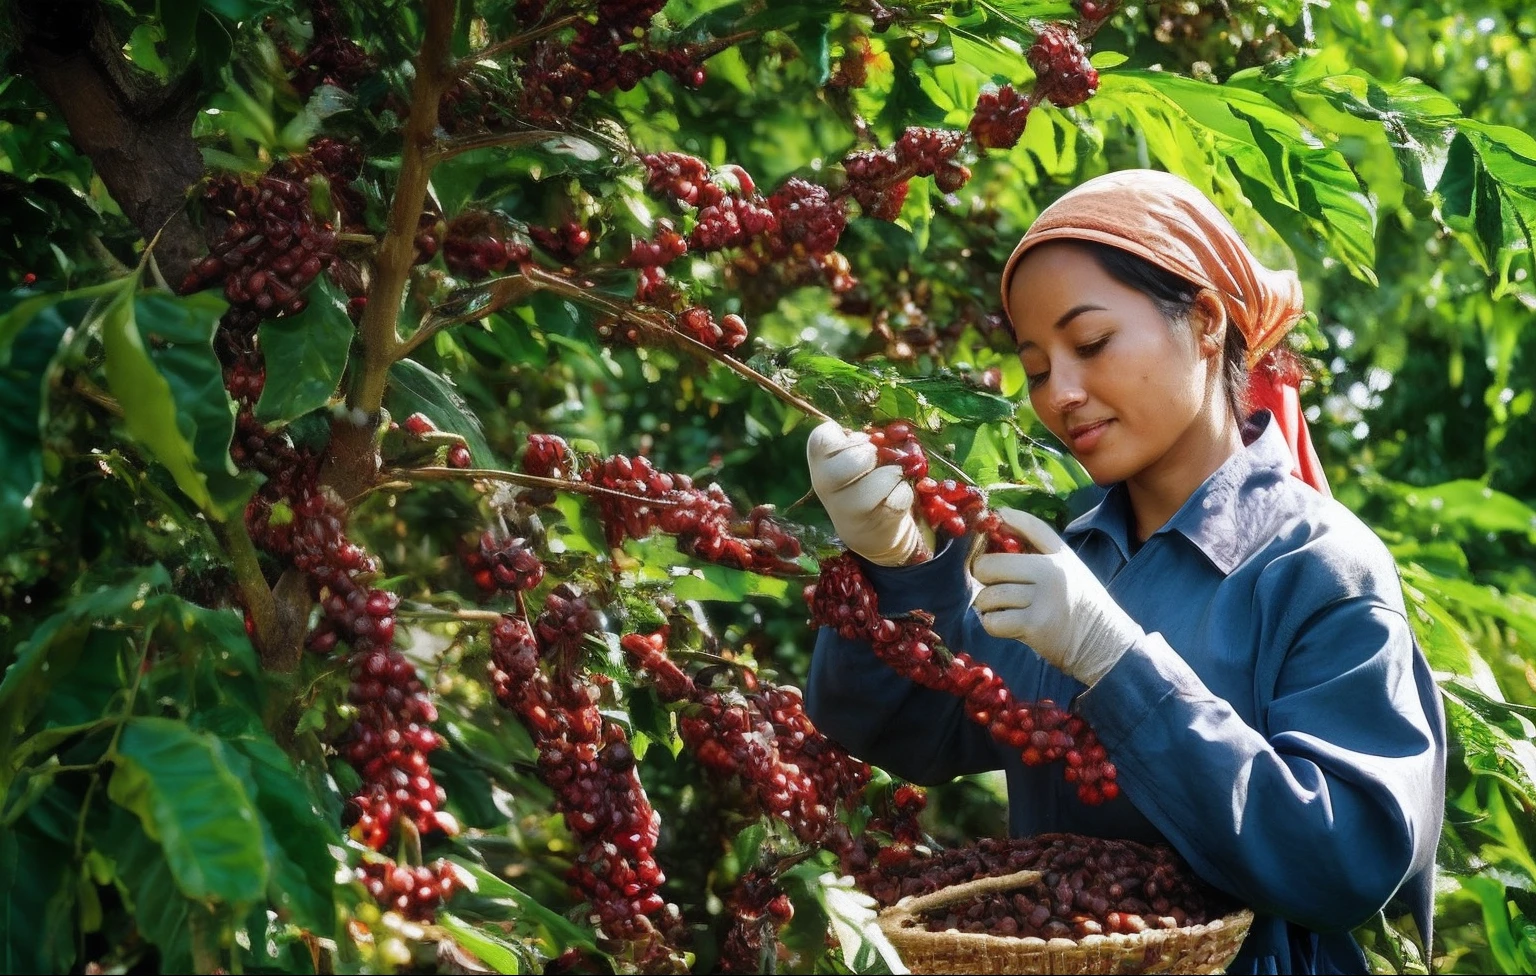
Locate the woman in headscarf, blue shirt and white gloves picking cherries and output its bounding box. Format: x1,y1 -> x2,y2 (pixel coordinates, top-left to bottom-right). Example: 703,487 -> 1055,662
808,171 -> 1445,973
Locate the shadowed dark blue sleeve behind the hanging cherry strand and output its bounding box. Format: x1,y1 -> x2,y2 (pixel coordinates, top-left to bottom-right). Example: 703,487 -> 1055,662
805,539 -> 1028,784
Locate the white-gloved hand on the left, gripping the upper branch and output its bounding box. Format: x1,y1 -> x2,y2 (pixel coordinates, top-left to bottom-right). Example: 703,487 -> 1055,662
805,420 -> 932,566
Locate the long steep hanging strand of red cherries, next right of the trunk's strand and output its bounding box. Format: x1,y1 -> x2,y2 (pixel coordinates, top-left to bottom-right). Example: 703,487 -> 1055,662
490,611 -> 680,956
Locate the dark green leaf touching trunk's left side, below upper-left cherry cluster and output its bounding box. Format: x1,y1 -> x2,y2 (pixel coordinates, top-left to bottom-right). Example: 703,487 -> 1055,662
257,275 -> 356,424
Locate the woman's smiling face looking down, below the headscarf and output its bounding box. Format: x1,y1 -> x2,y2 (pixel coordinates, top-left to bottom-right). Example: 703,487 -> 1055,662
1009,241 -> 1226,484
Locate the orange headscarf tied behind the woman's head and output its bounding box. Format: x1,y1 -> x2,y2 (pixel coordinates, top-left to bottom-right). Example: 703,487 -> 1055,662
1003,169 -> 1329,495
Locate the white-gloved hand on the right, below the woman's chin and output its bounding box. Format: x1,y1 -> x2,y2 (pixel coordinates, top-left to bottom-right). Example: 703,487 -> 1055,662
971,509 -> 1146,686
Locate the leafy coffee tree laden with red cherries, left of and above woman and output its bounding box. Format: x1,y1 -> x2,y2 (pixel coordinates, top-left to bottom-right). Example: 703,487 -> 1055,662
0,0 -> 1536,971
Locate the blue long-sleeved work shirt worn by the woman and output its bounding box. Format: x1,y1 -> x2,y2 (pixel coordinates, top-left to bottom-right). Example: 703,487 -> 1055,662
806,412 -> 1445,973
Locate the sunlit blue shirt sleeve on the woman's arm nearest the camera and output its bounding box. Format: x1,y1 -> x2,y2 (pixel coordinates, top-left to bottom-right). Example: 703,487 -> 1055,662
1078,596 -> 1445,931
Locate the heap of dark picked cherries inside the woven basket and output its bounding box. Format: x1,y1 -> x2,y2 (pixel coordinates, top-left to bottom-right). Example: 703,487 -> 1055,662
856,833 -> 1232,939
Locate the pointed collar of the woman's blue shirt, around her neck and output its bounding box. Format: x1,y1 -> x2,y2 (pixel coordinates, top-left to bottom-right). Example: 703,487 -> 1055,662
1063,410 -> 1293,573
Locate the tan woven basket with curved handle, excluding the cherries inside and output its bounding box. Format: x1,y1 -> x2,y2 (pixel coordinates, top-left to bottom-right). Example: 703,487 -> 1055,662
879,871 -> 1253,973
